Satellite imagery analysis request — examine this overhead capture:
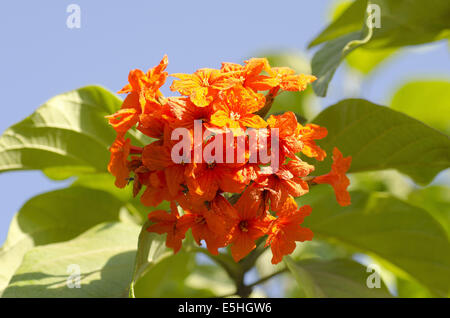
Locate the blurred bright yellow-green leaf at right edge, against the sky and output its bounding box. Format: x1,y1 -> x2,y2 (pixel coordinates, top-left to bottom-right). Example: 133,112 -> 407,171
390,80 -> 450,134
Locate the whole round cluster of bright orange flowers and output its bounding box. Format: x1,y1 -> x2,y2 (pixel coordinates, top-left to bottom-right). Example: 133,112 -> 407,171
107,56 -> 351,264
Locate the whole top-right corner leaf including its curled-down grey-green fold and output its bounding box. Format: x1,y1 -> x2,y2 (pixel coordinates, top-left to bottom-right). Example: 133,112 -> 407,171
310,0 -> 450,96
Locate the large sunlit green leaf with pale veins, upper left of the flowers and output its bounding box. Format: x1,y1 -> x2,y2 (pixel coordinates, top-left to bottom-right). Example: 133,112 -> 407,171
0,86 -> 121,179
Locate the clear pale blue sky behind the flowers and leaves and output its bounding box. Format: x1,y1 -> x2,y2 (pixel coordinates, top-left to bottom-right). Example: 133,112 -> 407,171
0,0 -> 450,243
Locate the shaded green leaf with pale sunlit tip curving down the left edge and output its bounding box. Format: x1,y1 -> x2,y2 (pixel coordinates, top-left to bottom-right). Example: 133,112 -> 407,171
0,187 -> 122,293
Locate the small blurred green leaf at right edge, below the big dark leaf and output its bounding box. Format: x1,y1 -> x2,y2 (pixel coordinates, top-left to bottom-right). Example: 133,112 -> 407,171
408,185 -> 450,238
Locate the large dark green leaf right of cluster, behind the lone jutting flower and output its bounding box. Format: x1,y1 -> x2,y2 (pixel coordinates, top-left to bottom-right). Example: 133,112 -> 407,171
313,99 -> 450,184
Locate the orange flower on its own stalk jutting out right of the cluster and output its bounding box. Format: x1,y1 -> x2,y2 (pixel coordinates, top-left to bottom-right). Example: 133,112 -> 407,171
313,147 -> 352,206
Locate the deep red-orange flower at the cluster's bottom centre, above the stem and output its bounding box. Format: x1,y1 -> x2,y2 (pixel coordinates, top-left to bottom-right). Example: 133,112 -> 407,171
229,189 -> 274,262
